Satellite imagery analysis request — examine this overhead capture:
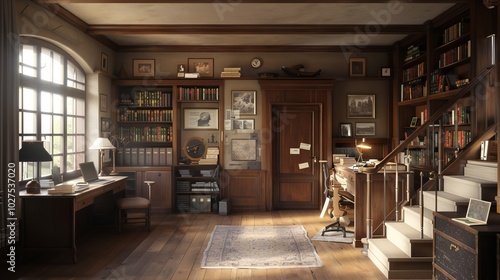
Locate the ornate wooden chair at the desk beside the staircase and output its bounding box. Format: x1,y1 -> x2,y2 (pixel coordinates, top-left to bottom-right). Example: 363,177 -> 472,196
321,165 -> 354,237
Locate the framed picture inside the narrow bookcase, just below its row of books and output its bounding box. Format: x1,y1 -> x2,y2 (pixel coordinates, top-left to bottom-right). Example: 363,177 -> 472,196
184,108 -> 219,129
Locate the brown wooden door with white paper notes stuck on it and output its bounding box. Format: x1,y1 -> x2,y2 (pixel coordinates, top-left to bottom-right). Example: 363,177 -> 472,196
272,104 -> 321,209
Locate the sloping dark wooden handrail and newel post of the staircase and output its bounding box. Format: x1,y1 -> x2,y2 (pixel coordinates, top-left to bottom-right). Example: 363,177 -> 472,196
358,66 -> 494,254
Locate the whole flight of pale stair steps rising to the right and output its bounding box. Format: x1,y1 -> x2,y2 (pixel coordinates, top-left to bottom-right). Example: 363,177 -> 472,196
368,160 -> 498,279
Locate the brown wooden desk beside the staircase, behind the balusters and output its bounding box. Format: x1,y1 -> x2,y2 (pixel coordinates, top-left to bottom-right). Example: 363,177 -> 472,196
335,165 -> 413,247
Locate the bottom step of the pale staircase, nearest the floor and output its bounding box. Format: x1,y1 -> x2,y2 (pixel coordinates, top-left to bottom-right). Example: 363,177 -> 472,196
368,238 -> 432,279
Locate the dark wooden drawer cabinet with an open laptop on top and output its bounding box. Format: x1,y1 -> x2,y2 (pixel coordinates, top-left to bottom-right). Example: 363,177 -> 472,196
433,212 -> 500,279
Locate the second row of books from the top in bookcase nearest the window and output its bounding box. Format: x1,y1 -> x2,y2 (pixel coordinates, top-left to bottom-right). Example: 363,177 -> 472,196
118,126 -> 174,142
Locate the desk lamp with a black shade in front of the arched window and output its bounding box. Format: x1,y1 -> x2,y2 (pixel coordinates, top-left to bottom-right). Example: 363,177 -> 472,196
19,140 -> 52,194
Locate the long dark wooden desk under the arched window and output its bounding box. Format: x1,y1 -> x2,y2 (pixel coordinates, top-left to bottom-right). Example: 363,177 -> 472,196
19,176 -> 127,263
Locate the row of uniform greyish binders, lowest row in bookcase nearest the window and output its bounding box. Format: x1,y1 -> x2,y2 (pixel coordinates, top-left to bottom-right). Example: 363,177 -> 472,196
116,147 -> 173,166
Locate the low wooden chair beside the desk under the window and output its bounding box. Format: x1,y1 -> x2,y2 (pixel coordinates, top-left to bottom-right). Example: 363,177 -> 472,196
116,181 -> 155,233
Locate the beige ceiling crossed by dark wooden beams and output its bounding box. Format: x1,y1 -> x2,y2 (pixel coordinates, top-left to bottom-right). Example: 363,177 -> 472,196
41,0 -> 467,52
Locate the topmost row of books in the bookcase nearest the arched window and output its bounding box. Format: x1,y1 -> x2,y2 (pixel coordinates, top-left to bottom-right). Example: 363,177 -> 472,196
120,91 -> 172,107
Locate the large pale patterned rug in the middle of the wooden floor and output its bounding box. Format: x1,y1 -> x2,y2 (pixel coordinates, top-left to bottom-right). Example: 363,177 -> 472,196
201,225 -> 322,269
